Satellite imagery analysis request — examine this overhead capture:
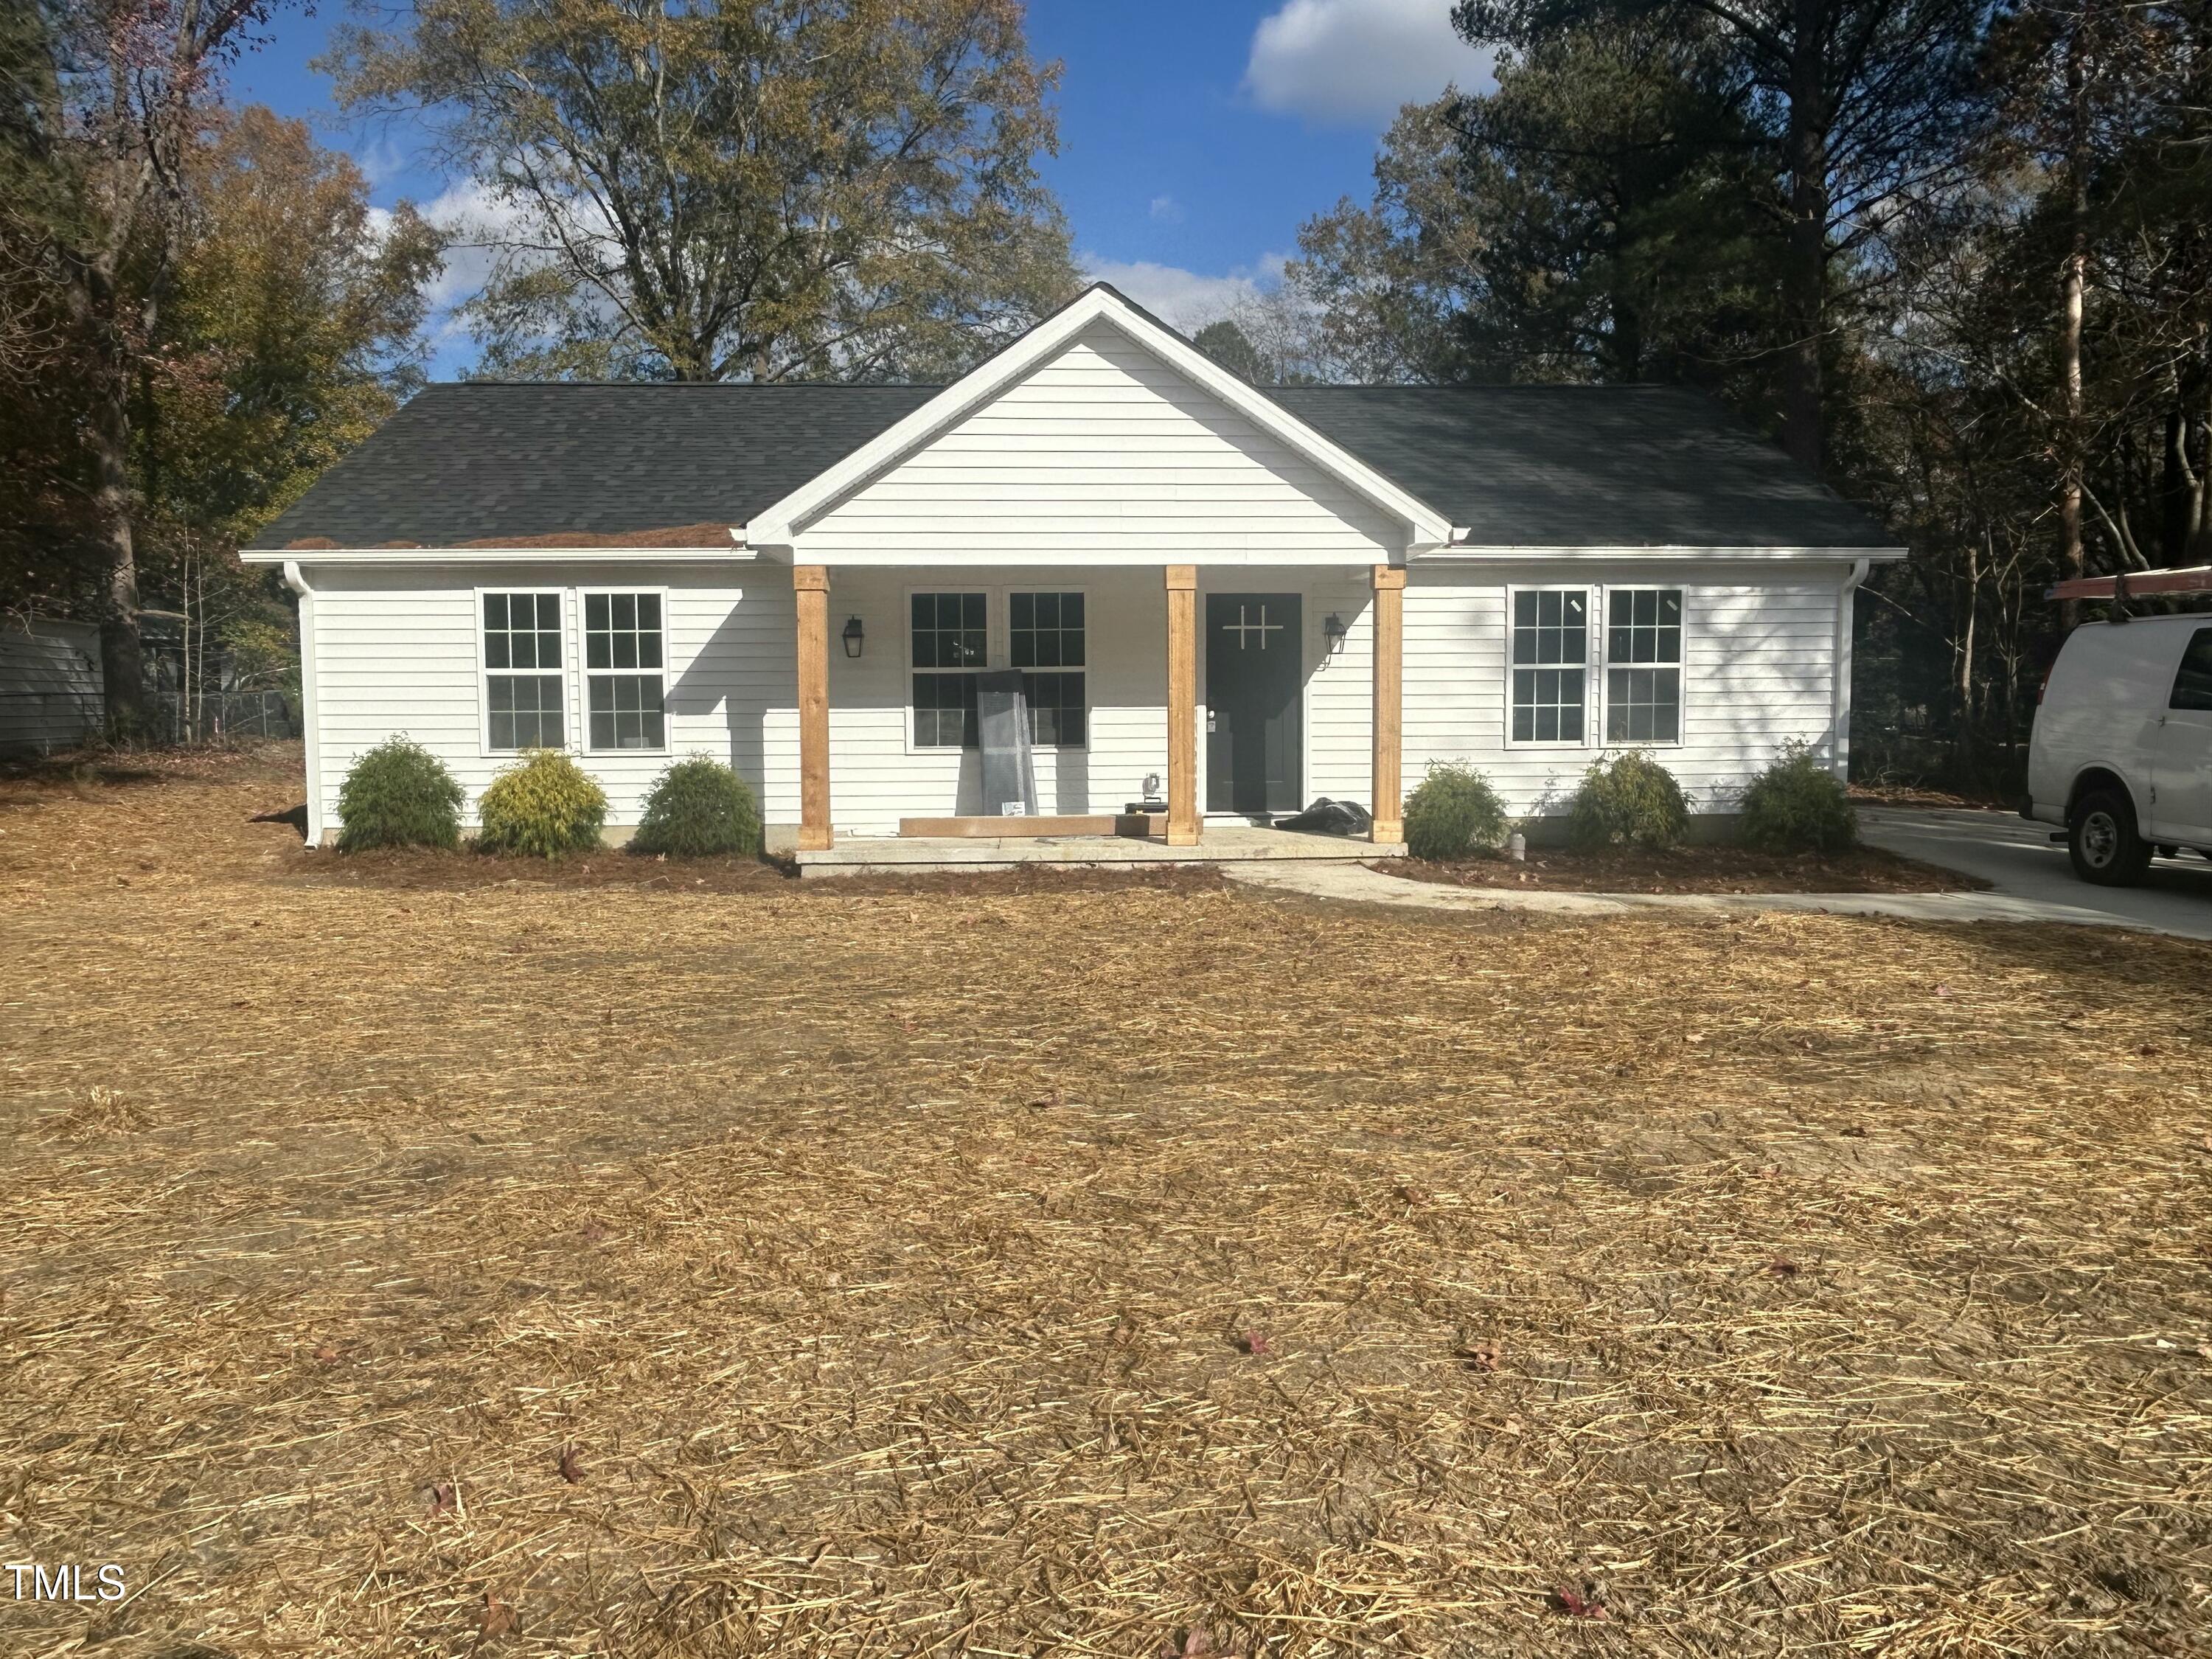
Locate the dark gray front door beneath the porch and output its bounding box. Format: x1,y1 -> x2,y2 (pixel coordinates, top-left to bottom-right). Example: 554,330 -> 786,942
1206,593 -> 1305,812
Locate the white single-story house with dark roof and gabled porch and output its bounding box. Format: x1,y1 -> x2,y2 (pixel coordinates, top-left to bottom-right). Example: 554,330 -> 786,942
246,285 -> 1902,854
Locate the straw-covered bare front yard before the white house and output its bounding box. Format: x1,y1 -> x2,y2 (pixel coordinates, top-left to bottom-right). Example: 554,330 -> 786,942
0,754 -> 2212,1659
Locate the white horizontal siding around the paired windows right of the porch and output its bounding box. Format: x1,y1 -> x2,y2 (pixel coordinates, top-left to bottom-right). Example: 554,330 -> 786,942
1405,564 -> 1845,816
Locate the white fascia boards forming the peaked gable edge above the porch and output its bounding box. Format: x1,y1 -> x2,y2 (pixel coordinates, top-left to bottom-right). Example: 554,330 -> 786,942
748,288 -> 1451,549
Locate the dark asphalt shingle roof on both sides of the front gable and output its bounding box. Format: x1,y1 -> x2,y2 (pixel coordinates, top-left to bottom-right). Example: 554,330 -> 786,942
254,380 -> 1891,549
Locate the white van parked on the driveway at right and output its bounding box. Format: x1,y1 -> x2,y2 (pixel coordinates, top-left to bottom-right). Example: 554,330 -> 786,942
2020,617 -> 2212,887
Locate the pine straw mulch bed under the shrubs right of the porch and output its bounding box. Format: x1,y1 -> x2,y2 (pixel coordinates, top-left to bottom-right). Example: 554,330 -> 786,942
1374,847 -> 1989,894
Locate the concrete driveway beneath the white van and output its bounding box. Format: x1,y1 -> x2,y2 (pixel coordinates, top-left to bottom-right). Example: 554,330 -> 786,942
1858,807 -> 2212,938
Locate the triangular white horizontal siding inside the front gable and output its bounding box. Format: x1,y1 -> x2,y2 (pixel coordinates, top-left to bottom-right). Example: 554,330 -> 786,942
799,325 -> 1405,566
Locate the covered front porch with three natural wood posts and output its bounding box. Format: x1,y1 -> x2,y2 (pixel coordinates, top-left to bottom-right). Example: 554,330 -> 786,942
783,560 -> 1405,869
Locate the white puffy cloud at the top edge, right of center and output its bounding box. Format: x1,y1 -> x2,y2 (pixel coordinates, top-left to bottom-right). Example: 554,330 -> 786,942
1243,0 -> 1491,126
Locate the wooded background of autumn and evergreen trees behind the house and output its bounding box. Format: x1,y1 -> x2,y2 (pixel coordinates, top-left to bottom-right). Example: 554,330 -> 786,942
0,0 -> 2212,792
